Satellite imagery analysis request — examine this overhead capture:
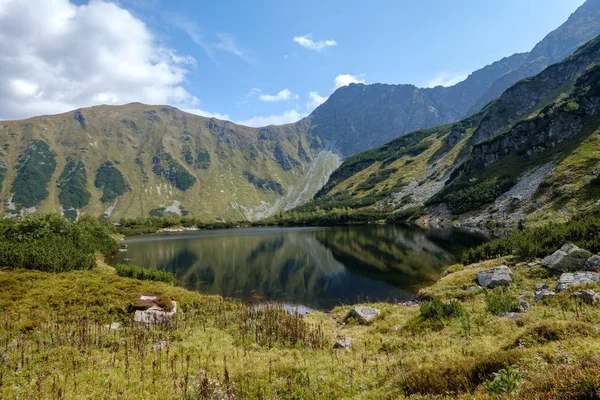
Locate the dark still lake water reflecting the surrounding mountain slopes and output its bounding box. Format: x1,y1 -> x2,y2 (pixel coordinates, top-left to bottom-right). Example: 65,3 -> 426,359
114,225 -> 486,309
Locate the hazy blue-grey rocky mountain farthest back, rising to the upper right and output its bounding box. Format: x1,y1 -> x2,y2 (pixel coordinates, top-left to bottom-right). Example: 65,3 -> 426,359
303,0 -> 600,157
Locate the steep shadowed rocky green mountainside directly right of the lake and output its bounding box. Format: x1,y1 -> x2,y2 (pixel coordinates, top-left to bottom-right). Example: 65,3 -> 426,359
310,36 -> 600,225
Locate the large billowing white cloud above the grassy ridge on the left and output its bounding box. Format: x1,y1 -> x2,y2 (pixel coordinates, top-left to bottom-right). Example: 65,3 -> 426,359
0,0 -> 217,119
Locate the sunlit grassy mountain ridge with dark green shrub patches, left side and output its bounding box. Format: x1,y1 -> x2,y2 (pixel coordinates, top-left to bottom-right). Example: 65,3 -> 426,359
0,103 -> 340,220
